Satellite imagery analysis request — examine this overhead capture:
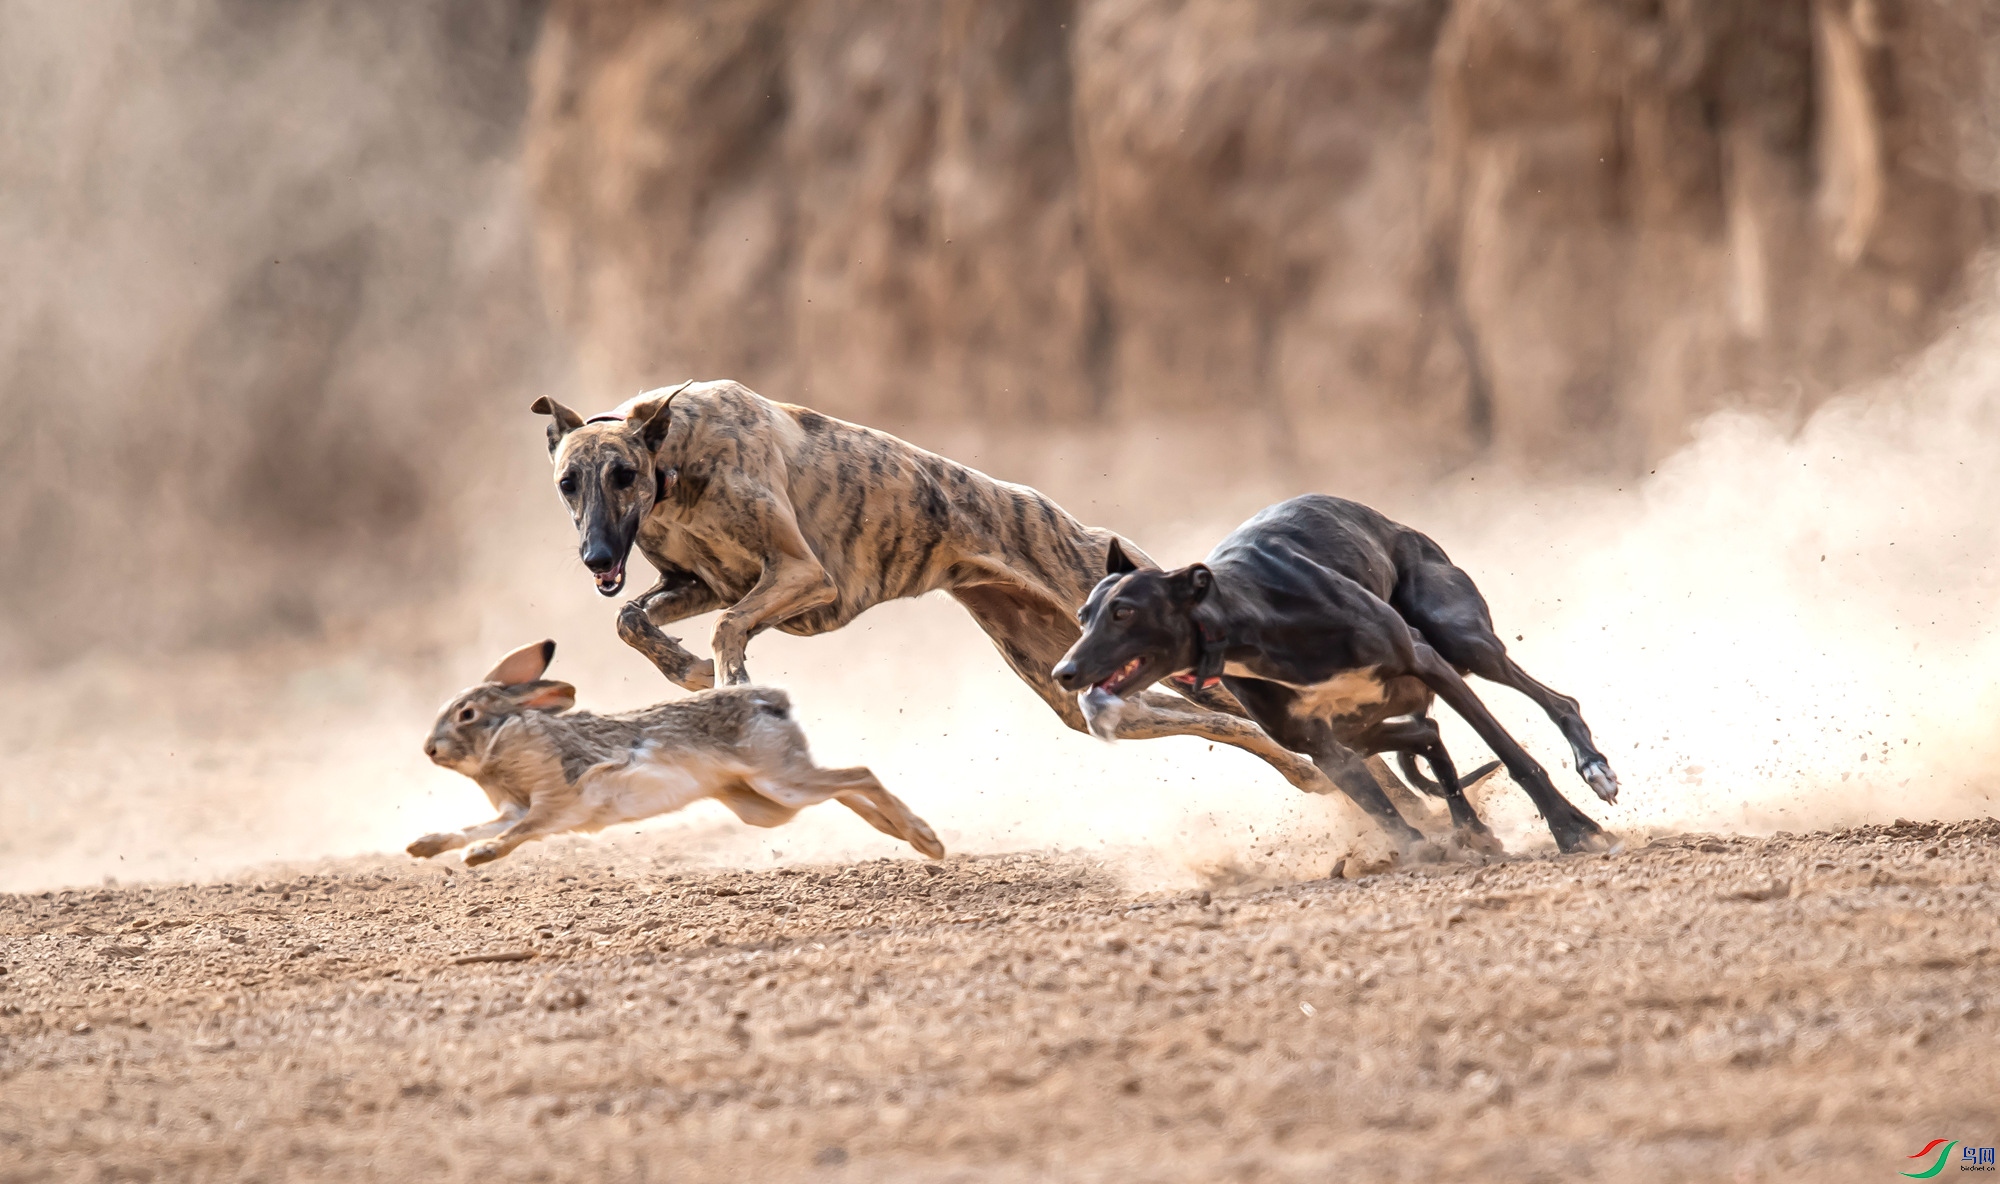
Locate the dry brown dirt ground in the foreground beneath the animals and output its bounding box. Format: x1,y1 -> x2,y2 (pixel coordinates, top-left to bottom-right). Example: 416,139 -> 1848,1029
0,820 -> 2000,1182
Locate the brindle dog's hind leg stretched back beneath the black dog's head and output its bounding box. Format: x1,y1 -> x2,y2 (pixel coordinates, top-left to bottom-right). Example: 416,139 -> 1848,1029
952,584 -> 1334,794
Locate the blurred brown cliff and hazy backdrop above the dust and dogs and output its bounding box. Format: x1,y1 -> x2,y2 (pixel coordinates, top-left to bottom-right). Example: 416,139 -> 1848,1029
0,0 -> 2000,662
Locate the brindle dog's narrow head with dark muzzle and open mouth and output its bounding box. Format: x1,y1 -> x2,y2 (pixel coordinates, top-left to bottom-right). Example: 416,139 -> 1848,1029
532,382 -> 688,596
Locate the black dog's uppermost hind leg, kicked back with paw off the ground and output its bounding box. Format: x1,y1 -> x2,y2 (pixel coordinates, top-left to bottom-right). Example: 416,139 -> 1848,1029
1390,544 -> 1618,802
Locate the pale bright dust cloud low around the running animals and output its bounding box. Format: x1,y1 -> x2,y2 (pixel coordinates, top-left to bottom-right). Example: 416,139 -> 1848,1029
0,284 -> 2000,888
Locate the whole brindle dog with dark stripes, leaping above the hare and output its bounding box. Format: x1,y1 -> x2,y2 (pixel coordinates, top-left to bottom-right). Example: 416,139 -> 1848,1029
534,382 -> 1344,794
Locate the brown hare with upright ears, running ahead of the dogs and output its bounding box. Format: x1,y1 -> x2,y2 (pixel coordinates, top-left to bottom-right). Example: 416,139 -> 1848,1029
408,642 -> 944,864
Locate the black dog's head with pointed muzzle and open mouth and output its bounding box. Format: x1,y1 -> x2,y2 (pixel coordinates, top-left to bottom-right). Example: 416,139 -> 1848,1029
1050,540 -> 1214,698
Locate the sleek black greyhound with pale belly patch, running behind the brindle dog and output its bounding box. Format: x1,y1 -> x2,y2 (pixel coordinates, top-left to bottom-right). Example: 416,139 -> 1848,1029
1052,494 -> 1618,852
